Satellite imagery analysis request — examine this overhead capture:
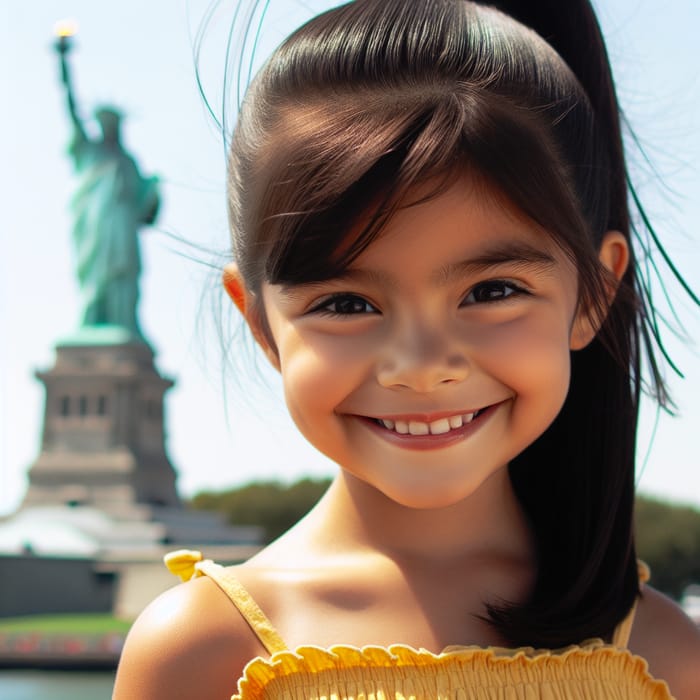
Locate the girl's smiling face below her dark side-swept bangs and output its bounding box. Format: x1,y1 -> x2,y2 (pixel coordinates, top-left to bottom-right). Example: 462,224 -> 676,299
254,178 -> 592,508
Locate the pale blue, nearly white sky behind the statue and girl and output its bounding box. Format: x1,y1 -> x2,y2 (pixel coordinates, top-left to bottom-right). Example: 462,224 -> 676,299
0,0 -> 700,514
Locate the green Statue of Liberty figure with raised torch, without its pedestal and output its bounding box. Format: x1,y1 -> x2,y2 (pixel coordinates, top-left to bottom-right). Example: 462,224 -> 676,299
56,28 -> 160,340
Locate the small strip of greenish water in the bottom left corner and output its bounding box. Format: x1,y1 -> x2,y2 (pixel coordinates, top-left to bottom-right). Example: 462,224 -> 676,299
0,670 -> 114,700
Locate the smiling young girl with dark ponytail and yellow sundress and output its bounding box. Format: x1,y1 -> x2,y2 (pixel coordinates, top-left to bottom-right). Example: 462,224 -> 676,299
115,0 -> 700,700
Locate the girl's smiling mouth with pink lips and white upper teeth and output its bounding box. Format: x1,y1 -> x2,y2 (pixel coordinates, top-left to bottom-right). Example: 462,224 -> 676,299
357,401 -> 505,450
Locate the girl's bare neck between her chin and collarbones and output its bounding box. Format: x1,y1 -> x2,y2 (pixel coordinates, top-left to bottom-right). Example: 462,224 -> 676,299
303,468 -> 534,565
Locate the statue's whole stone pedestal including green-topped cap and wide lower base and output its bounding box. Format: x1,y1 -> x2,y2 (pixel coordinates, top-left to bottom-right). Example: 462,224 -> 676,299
0,334 -> 263,616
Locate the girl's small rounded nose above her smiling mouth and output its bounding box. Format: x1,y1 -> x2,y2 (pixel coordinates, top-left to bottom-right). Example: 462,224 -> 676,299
377,328 -> 469,393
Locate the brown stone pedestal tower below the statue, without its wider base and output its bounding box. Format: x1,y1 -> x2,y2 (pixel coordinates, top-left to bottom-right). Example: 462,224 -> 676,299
22,341 -> 180,520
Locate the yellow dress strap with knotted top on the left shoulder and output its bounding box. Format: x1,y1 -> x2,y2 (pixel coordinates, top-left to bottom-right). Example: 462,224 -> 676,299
165,550 -> 288,655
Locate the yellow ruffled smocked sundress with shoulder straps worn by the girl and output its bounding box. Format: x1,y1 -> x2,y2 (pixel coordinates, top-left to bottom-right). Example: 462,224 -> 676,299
166,551 -> 673,700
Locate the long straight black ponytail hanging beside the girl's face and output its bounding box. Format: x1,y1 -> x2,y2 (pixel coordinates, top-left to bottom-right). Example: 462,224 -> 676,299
489,0 -> 644,647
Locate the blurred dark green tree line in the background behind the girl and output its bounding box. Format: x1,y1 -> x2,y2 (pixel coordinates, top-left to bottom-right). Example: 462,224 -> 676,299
191,479 -> 700,599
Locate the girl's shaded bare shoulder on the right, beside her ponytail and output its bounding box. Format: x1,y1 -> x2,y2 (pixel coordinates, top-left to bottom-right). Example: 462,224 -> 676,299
630,586 -> 700,700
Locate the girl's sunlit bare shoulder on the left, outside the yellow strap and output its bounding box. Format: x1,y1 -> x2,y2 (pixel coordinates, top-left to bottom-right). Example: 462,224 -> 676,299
113,577 -> 261,700
